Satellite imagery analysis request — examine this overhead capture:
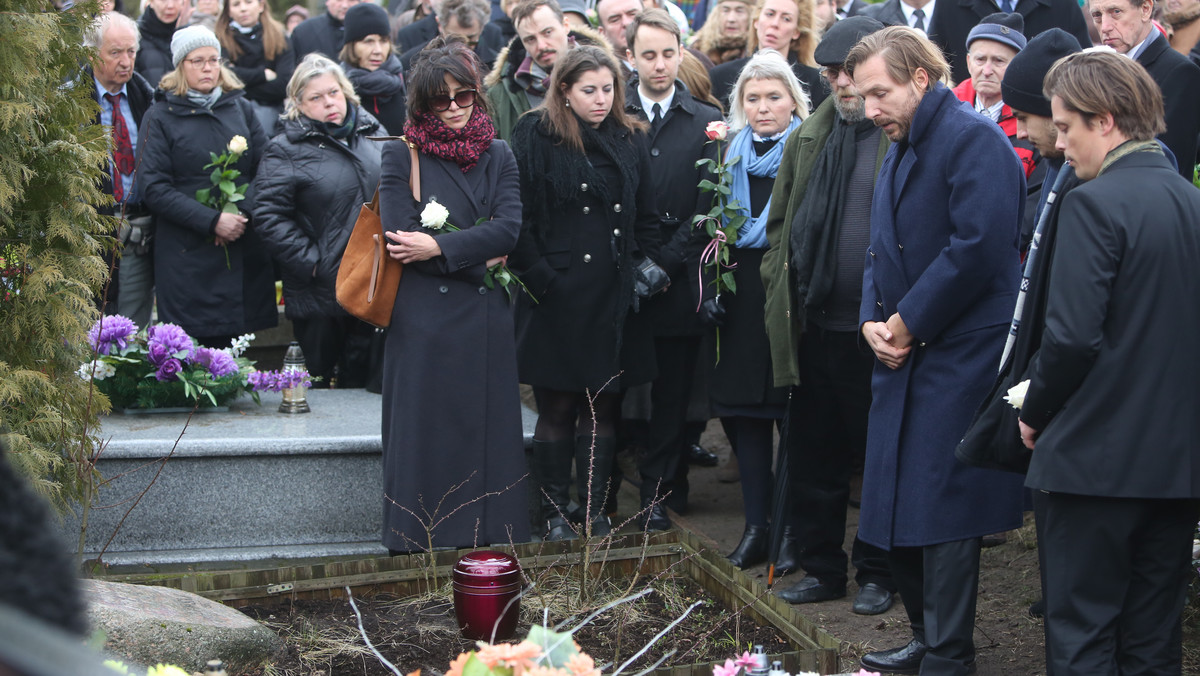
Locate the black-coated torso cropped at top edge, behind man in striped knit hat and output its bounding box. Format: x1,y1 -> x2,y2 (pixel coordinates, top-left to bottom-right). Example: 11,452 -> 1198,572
926,0 -> 1099,82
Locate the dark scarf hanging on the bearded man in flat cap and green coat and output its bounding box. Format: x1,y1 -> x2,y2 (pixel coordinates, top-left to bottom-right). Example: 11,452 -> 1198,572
790,118 -> 875,325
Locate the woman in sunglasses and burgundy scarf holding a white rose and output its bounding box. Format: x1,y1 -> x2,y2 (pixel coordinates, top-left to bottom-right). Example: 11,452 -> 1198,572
379,38 -> 529,552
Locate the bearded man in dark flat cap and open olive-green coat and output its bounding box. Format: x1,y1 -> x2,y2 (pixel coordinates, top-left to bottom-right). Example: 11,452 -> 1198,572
761,17 -> 895,615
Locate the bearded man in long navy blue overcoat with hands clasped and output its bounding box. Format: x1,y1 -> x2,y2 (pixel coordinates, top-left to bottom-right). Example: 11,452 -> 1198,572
845,26 -> 1025,675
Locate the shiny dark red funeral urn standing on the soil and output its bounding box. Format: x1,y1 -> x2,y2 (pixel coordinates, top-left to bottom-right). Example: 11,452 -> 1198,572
454,551 -> 521,641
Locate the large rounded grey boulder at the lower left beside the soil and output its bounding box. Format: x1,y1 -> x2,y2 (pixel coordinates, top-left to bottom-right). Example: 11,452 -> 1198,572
83,580 -> 283,676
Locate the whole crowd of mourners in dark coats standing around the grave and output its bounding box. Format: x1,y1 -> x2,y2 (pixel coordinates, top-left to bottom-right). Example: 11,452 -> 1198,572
82,0 -> 1200,675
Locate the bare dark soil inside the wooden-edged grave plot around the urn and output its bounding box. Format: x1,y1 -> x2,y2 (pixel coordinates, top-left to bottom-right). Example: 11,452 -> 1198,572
240,578 -> 791,676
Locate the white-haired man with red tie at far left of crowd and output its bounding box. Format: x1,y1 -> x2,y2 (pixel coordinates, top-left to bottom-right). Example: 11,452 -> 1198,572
84,12 -> 154,328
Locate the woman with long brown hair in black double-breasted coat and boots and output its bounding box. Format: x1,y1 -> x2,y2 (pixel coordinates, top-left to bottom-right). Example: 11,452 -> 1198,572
512,46 -> 659,540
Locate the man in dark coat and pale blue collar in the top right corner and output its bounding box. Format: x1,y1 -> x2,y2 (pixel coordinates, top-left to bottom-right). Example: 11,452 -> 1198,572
1092,0 -> 1200,180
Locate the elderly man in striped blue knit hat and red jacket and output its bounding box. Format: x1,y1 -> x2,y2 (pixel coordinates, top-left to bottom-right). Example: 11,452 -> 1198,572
954,12 -> 1045,252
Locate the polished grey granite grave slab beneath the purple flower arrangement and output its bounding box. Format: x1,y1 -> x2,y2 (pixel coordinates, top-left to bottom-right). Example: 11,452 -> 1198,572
62,389 -> 536,566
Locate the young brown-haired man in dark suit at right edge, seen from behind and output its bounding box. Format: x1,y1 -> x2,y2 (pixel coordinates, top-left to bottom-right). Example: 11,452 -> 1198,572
1020,52 -> 1200,676
